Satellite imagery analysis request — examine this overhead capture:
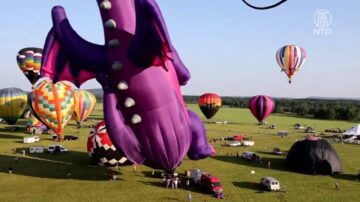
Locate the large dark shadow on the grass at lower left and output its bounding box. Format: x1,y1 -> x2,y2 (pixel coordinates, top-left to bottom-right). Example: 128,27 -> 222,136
0,152 -> 110,181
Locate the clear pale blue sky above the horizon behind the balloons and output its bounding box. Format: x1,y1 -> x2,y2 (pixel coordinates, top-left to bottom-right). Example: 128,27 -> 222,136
0,0 -> 360,98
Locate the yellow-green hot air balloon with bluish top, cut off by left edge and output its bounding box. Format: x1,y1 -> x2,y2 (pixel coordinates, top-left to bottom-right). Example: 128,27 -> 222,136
0,88 -> 27,125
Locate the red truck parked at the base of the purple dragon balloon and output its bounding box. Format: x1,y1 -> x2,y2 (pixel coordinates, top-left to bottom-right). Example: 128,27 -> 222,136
190,169 -> 223,196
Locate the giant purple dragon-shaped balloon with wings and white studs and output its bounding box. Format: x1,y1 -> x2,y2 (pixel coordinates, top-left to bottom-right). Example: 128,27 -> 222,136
42,0 -> 215,170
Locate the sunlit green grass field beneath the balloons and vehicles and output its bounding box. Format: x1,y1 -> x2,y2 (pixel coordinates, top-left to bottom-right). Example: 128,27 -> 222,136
0,105 -> 360,202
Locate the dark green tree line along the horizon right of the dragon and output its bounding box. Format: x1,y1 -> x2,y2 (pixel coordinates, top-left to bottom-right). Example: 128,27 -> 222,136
184,96 -> 360,122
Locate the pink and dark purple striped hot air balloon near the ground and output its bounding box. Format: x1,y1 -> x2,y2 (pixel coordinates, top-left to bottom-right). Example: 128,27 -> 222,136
249,95 -> 275,124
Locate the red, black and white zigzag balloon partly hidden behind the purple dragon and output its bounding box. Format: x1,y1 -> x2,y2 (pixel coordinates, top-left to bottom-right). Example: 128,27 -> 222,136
87,121 -> 132,166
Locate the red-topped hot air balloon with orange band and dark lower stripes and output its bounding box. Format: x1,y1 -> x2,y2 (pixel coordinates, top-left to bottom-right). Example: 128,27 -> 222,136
198,93 -> 221,119
